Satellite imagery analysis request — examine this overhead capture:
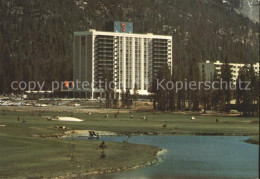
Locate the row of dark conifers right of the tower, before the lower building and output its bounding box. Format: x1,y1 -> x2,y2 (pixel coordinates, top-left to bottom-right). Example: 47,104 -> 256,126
151,57 -> 259,116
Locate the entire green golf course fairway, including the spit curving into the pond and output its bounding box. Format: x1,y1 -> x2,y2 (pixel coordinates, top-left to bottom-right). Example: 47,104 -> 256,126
0,111 -> 259,178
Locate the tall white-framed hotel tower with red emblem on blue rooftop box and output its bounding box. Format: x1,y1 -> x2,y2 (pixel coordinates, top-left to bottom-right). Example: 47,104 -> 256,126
73,22 -> 172,98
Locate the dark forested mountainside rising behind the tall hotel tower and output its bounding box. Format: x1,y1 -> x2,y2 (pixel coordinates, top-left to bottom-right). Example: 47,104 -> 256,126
0,0 -> 259,92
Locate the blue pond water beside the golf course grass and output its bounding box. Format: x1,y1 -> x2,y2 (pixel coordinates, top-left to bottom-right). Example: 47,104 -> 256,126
82,136 -> 259,179
